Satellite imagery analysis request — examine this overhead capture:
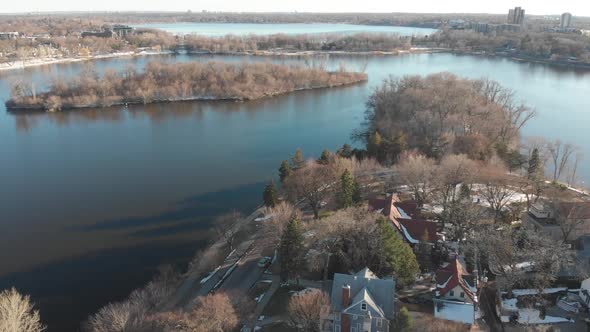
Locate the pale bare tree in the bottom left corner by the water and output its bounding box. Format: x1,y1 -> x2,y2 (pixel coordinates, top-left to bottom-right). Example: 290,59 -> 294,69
0,288 -> 45,332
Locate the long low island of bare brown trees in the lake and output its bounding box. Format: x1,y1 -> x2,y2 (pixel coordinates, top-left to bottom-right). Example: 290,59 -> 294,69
6,62 -> 367,111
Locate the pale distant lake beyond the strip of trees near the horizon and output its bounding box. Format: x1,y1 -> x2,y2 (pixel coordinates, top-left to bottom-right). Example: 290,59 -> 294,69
133,23 -> 436,37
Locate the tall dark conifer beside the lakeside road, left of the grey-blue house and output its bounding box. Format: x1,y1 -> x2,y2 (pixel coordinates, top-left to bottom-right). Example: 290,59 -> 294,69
279,218 -> 303,281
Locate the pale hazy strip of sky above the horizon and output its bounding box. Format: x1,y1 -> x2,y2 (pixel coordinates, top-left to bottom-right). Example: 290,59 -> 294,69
0,0 -> 590,16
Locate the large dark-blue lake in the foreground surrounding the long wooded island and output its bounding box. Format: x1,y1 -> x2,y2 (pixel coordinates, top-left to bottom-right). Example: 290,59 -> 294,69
0,54 -> 590,331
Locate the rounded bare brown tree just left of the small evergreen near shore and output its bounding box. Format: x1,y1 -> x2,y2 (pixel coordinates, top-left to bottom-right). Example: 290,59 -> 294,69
285,162 -> 336,219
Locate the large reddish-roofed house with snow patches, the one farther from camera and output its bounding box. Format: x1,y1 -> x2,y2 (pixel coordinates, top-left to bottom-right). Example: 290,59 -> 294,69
369,195 -> 441,245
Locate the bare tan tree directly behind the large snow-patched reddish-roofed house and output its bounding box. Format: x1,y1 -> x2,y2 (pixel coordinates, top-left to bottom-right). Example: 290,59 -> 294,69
395,152 -> 435,204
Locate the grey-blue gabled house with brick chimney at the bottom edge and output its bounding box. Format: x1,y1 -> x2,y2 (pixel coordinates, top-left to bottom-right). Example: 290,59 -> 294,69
321,268 -> 395,332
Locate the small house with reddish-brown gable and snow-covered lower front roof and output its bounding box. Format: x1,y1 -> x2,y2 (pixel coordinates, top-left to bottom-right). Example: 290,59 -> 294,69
434,256 -> 478,324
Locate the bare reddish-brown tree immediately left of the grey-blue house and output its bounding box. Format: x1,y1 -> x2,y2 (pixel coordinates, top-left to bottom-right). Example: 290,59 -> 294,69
288,289 -> 330,332
